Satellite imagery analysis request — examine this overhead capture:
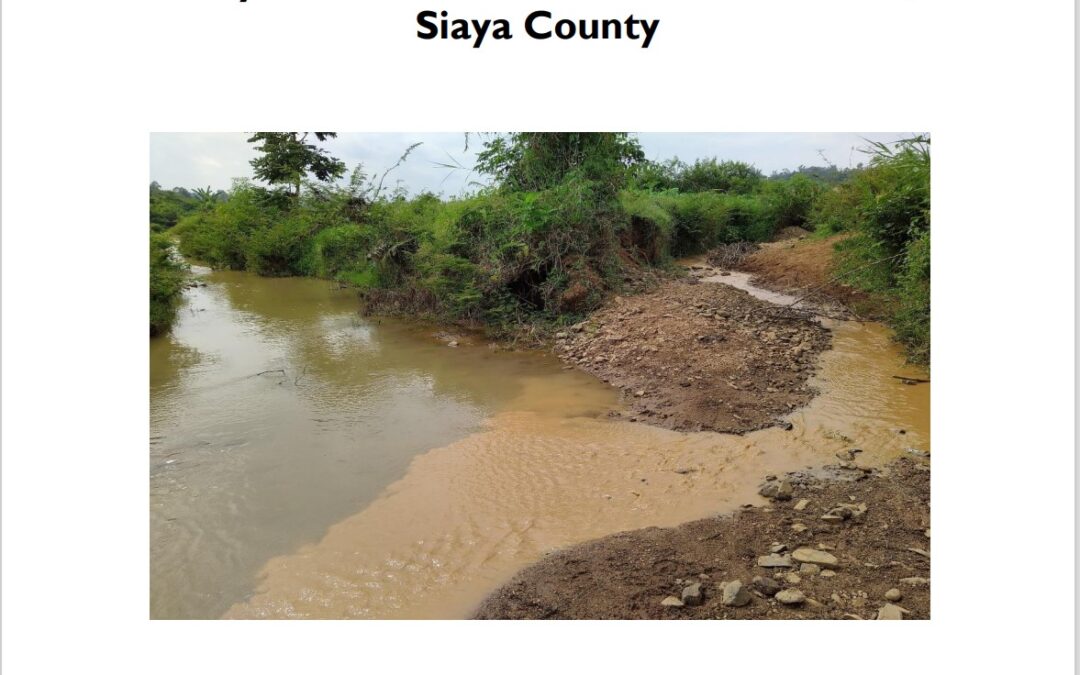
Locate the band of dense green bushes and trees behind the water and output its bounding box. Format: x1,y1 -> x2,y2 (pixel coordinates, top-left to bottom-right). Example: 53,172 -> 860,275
151,132 -> 929,360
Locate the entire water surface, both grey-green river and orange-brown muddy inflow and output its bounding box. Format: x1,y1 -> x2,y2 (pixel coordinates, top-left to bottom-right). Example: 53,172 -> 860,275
150,264 -> 930,618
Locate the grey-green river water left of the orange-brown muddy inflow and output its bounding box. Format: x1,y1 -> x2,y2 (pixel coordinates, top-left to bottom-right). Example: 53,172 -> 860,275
150,268 -> 616,618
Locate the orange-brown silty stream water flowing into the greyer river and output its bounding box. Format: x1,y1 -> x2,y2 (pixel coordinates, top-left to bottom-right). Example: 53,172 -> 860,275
226,272 -> 930,618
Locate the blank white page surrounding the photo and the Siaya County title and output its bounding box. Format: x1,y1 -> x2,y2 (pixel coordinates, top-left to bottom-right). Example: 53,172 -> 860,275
2,0 -> 1075,675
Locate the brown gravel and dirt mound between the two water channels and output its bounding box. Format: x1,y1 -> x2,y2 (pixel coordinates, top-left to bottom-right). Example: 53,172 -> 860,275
555,280 -> 829,433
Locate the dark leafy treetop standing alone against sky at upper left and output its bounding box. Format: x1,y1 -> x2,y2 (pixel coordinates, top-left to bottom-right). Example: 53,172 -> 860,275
247,132 -> 345,202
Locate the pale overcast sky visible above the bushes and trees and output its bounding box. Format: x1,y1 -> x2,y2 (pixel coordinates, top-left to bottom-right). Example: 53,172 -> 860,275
150,132 -> 912,195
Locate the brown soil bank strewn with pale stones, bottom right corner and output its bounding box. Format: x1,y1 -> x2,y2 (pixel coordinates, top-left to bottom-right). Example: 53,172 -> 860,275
475,458 -> 930,619
